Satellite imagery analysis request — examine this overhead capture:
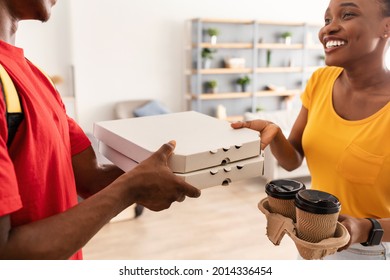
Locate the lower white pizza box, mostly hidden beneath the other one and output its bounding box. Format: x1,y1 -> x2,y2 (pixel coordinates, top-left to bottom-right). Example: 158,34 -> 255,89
99,142 -> 264,189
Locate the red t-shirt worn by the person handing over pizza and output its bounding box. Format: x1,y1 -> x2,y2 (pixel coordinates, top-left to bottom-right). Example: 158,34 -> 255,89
0,41 -> 91,259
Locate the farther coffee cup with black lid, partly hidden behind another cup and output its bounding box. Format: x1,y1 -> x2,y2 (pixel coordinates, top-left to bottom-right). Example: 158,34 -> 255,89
265,179 -> 306,221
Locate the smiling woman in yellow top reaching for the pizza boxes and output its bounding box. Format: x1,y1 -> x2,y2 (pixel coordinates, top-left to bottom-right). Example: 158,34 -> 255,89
233,0 -> 390,259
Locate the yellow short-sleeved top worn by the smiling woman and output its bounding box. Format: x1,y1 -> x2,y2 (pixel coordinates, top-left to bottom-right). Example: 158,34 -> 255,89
301,67 -> 390,218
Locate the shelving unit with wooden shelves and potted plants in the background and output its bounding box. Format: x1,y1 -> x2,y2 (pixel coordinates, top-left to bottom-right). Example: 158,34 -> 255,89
185,18 -> 323,120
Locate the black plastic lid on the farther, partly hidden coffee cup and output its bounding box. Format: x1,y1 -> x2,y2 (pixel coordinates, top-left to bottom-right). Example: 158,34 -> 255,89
265,179 -> 306,199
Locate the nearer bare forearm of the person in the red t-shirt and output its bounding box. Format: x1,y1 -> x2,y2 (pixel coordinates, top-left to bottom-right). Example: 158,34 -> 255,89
0,184 -> 132,259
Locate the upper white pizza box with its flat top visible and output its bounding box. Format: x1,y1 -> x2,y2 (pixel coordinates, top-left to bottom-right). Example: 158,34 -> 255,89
94,111 -> 260,173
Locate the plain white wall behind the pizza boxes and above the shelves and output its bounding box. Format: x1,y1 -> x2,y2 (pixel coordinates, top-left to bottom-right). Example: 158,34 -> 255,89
19,0 -> 328,131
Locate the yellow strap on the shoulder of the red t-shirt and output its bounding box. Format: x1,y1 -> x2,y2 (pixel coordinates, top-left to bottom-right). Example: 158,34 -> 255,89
0,64 -> 22,113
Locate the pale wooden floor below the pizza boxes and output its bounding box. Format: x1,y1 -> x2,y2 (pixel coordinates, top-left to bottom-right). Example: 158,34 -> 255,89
83,178 -> 306,260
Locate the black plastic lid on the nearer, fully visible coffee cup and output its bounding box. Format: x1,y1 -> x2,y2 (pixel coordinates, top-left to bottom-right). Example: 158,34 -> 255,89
295,190 -> 341,214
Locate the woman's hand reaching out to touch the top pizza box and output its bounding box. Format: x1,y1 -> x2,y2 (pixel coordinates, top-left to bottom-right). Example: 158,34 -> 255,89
231,120 -> 280,150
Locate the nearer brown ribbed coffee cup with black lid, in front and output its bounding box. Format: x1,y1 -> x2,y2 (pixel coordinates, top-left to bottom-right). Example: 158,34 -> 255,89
295,189 -> 341,243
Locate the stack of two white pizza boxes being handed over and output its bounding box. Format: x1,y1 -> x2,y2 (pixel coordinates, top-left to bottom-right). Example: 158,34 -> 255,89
94,111 -> 264,189
